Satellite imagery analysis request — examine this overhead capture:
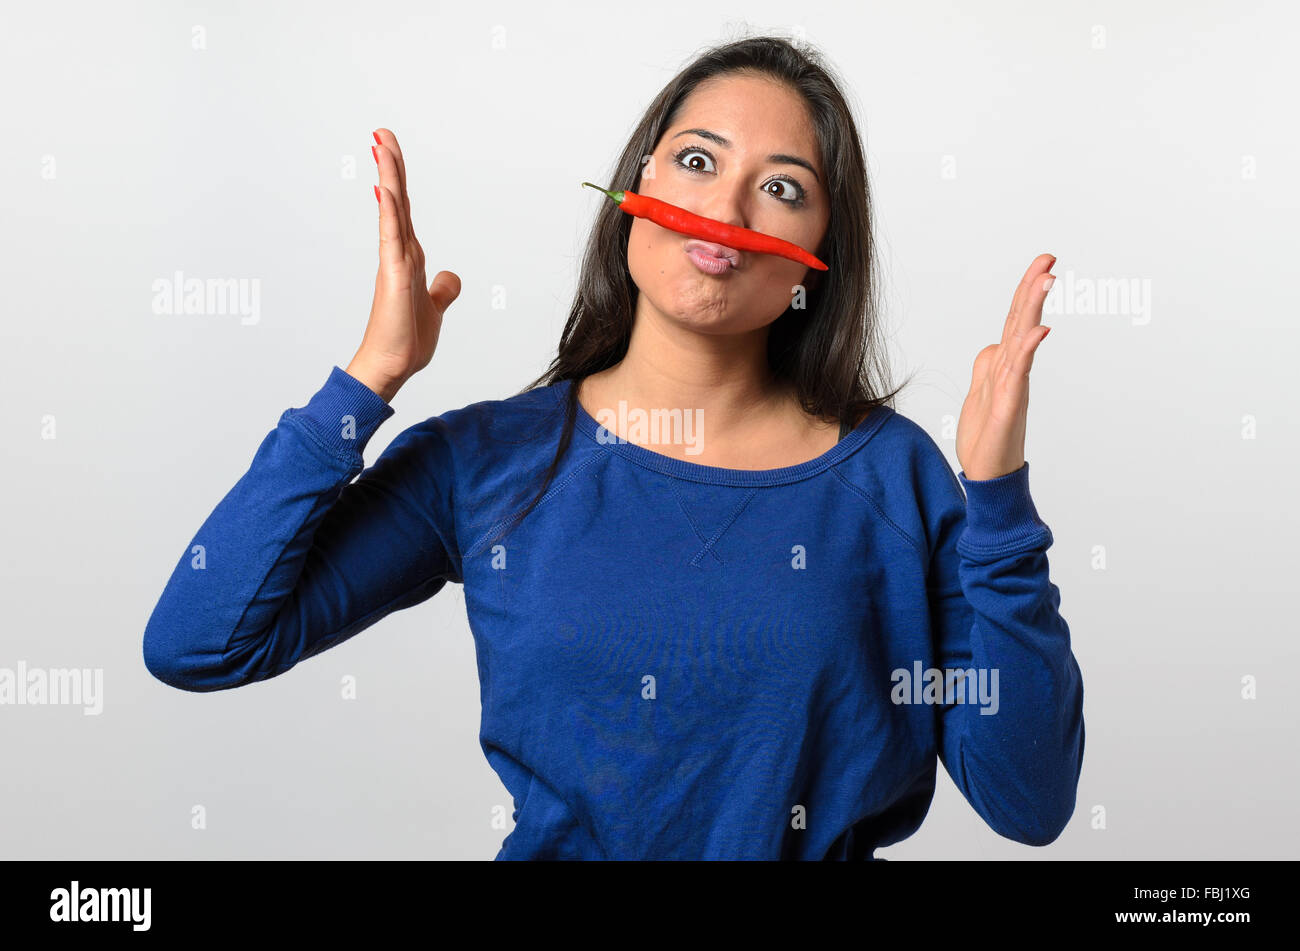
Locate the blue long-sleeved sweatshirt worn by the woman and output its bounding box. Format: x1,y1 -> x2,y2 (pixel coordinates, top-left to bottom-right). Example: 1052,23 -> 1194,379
143,366 -> 1084,859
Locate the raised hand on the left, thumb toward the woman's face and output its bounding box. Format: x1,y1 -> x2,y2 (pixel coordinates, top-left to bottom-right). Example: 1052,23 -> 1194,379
347,129 -> 460,401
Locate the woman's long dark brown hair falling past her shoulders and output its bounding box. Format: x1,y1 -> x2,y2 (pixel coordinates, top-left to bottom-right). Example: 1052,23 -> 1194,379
483,36 -> 906,543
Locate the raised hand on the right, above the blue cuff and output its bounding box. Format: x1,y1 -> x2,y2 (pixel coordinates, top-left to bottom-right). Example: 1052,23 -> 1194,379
957,255 -> 1056,482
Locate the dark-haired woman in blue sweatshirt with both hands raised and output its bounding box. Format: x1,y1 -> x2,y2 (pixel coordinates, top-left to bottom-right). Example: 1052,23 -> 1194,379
143,38 -> 1084,859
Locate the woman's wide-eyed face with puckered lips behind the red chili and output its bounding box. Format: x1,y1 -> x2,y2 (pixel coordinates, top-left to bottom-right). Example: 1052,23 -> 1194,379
628,75 -> 831,334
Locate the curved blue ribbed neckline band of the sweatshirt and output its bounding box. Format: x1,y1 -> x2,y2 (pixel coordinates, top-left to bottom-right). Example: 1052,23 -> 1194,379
555,378 -> 894,486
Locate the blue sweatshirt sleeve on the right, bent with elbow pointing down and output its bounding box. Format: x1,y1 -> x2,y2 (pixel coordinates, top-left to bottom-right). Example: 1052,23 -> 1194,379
928,460 -> 1083,846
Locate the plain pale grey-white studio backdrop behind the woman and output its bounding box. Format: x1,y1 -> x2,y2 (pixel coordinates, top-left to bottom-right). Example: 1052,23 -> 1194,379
0,1 -> 1300,859
